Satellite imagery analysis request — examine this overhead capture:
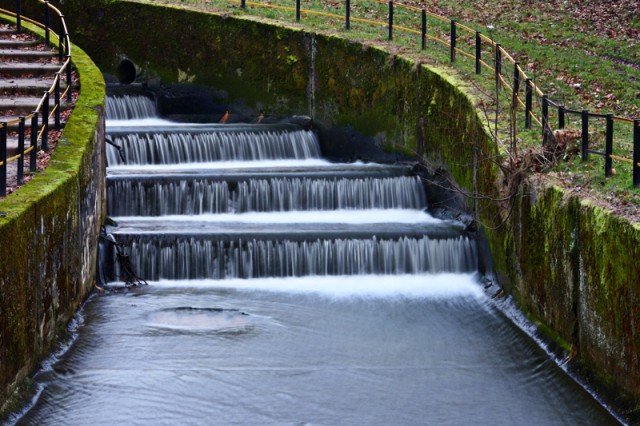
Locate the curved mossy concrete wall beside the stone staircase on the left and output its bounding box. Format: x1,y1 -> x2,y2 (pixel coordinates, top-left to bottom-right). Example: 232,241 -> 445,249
0,15 -> 105,406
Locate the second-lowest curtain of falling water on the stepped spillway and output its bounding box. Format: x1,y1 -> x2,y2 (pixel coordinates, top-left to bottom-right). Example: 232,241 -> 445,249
107,177 -> 426,216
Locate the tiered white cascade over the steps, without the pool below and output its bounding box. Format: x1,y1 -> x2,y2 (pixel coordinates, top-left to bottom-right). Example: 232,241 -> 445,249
102,98 -> 477,280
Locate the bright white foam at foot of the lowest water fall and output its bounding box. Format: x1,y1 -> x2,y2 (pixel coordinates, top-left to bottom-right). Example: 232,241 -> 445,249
149,273 -> 486,300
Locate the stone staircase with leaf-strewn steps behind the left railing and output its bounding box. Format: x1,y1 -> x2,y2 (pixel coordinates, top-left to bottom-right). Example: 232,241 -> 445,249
0,20 -> 66,191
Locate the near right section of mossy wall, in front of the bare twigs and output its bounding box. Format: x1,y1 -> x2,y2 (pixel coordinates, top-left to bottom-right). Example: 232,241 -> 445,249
510,186 -> 640,410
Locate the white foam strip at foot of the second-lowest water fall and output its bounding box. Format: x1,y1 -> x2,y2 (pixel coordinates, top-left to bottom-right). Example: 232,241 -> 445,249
113,209 -> 444,224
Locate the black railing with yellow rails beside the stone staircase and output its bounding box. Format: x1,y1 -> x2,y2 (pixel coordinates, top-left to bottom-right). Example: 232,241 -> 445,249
0,0 -> 72,197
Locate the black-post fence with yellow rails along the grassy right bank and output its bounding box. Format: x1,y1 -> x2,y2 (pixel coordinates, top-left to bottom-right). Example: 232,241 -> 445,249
226,0 -> 640,187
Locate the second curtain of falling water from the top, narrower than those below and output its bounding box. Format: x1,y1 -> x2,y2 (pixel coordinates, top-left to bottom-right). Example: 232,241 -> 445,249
107,129 -> 320,166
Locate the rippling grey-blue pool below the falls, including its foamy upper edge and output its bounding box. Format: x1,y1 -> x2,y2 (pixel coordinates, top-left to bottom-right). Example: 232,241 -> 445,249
13,274 -> 613,425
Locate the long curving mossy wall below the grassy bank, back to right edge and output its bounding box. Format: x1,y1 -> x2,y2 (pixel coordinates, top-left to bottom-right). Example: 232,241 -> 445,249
16,0 -> 640,412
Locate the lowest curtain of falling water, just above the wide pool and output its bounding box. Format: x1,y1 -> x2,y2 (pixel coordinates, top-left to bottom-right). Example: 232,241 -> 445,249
110,236 -> 477,280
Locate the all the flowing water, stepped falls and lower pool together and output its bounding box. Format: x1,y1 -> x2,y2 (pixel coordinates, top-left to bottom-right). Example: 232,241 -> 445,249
11,98 -> 615,425
